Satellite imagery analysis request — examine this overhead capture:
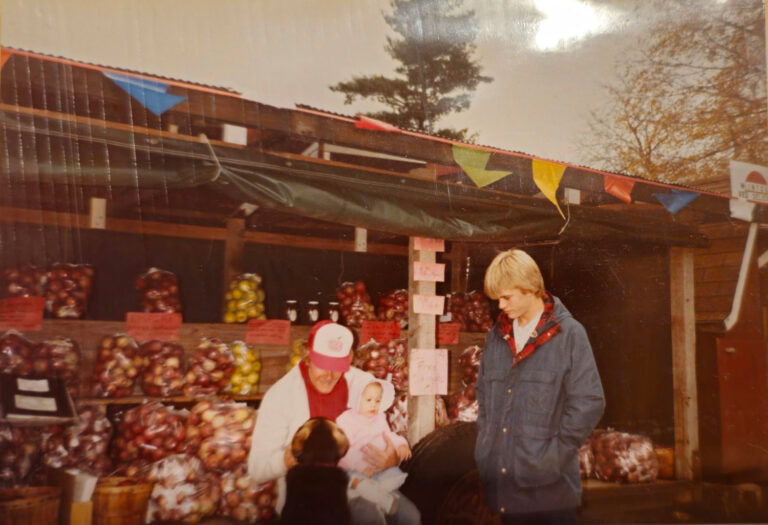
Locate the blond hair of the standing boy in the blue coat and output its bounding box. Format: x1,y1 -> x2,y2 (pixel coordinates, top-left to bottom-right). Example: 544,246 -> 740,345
484,249 -> 546,300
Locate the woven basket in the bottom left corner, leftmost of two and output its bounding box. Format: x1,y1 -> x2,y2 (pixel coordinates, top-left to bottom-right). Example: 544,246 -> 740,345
0,487 -> 61,525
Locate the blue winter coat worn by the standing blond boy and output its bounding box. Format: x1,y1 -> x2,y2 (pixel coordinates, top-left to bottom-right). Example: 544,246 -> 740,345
475,297 -> 605,514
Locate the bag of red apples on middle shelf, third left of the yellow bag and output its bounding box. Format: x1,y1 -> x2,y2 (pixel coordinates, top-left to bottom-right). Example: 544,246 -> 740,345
93,334 -> 144,397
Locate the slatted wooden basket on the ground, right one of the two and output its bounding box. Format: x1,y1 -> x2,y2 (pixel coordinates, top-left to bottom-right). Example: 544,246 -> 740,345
93,477 -> 152,525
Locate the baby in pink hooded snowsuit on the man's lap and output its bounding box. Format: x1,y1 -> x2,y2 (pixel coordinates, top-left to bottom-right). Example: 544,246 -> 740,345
336,379 -> 411,514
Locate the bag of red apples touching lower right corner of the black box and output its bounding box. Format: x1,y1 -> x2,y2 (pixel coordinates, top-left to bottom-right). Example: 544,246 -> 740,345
41,405 -> 112,476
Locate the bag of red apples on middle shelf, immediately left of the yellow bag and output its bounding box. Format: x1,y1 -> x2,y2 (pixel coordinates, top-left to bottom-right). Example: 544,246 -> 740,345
184,337 -> 235,396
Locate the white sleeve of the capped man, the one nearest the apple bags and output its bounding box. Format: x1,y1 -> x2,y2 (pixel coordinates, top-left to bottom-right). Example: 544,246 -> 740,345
248,378 -> 290,483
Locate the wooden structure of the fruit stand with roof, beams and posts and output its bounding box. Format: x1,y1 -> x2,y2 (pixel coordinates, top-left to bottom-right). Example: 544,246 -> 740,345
0,50 -> 760,520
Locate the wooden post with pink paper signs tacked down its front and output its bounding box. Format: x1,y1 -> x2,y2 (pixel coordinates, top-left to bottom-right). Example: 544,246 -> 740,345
408,237 -> 436,446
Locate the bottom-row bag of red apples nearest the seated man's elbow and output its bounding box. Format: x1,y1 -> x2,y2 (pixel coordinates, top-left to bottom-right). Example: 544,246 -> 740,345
217,465 -> 277,523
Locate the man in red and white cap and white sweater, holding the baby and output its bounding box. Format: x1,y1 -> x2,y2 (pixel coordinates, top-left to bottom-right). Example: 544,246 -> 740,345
248,321 -> 420,525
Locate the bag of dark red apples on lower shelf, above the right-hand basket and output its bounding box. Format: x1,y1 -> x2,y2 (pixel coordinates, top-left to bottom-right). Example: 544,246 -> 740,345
112,401 -> 187,465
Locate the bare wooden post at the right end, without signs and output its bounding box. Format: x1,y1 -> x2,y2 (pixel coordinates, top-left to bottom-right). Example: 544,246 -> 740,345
669,247 -> 701,480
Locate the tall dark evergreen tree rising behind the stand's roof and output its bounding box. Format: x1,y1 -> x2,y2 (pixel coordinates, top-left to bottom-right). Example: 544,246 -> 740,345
330,0 -> 492,140
